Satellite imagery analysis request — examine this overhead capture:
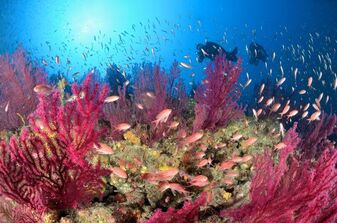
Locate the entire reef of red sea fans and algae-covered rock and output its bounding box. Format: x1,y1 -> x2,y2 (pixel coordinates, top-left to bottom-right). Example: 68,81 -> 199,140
0,48 -> 337,223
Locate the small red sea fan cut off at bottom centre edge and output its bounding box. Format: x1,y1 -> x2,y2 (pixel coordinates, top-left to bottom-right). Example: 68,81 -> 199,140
145,193 -> 206,223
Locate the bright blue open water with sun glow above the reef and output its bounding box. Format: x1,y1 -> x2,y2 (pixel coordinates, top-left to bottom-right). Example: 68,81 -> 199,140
0,0 -> 337,109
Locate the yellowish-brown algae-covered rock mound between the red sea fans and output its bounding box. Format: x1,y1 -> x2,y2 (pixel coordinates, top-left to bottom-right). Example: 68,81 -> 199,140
77,118 -> 281,222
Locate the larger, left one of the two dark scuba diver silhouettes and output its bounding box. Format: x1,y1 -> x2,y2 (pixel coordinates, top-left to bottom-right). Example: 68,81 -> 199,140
197,41 -> 238,63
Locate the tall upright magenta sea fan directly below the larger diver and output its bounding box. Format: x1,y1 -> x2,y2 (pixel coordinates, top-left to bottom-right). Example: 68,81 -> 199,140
193,53 -> 242,131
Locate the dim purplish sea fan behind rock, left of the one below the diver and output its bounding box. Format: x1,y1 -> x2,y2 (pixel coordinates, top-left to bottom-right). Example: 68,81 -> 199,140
134,61 -> 187,144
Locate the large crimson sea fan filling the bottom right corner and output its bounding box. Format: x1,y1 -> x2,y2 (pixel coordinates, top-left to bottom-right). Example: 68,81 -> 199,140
221,125 -> 337,223
